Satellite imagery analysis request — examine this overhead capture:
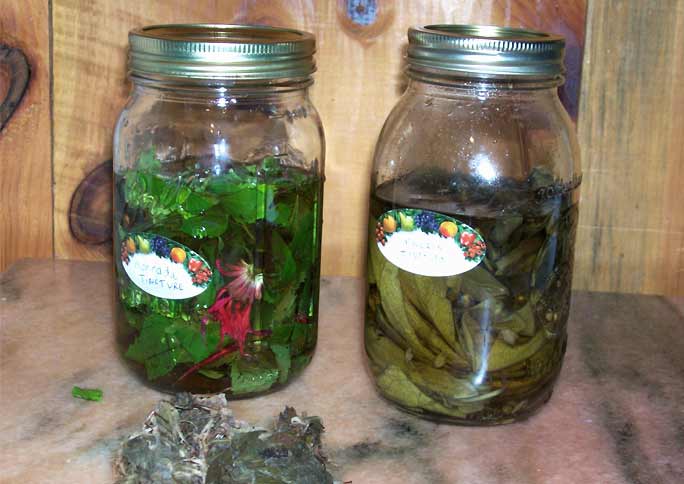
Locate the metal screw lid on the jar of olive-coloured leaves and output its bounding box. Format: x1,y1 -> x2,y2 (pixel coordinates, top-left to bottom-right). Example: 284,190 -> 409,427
408,25 -> 565,79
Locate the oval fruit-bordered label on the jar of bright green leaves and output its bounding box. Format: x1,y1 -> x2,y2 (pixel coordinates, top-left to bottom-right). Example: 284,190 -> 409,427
121,233 -> 212,299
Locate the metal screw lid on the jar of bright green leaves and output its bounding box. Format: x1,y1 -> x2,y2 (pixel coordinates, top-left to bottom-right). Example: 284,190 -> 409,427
128,24 -> 316,81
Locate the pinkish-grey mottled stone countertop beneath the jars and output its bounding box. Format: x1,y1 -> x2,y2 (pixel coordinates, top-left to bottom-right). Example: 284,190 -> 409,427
0,261 -> 684,484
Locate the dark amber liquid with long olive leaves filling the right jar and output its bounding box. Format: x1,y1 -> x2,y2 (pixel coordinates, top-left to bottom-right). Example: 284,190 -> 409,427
365,170 -> 577,425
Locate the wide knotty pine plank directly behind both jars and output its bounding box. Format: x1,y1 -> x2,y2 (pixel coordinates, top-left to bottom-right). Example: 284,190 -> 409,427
54,0 -> 586,275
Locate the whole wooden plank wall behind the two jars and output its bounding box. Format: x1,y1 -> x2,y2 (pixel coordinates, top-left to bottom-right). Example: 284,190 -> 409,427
0,0 -> 684,294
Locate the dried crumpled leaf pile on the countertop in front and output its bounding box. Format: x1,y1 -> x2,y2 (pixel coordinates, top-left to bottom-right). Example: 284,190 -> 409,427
115,393 -> 334,484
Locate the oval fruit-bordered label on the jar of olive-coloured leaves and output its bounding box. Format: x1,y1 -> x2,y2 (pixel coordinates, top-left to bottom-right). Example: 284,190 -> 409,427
375,208 -> 486,277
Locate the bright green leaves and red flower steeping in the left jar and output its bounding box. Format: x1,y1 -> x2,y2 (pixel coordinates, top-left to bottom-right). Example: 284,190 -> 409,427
115,151 -> 321,395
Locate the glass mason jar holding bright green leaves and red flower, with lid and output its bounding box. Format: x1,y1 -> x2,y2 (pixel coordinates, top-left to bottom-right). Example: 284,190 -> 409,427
114,25 -> 324,397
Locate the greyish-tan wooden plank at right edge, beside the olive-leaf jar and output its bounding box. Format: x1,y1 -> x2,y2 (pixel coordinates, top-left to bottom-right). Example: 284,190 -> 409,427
575,0 -> 684,295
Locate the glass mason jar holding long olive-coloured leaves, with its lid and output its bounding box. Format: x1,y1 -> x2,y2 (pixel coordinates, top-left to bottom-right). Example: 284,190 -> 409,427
365,25 -> 581,425
